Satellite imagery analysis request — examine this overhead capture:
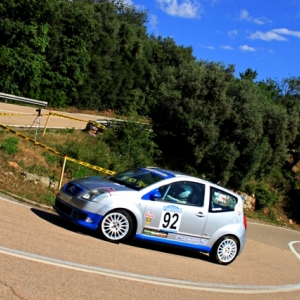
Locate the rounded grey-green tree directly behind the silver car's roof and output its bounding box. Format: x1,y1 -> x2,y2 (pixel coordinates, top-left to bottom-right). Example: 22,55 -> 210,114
151,61 -> 234,179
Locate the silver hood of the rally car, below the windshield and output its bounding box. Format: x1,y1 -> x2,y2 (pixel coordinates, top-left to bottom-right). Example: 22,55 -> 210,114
73,176 -> 134,192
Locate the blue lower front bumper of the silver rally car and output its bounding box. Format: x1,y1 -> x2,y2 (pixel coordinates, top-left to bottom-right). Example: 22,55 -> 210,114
53,197 -> 103,230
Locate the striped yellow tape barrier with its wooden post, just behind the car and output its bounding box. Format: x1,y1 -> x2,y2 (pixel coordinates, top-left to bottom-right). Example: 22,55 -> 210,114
0,123 -> 116,189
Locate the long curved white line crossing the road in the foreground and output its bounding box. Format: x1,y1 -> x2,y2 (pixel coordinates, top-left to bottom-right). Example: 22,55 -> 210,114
0,246 -> 300,294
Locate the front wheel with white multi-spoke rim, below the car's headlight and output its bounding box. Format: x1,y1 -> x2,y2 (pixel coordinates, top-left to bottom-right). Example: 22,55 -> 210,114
99,209 -> 133,243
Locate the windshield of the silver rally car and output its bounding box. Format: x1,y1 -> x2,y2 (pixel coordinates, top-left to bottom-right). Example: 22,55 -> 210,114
107,168 -> 169,191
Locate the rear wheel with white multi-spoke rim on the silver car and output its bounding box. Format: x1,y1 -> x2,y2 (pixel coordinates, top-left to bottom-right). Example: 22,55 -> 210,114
211,235 -> 239,265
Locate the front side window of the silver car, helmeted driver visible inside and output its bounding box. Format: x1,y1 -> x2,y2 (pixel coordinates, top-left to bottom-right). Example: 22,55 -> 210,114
158,181 -> 205,207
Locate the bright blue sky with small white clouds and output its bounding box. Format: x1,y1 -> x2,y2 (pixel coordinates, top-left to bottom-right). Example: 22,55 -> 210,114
125,0 -> 300,81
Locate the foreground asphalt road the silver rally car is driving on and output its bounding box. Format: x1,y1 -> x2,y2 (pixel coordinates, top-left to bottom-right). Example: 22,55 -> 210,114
0,195 -> 300,299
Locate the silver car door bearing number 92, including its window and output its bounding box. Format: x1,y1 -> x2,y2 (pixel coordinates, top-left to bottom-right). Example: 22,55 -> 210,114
143,181 -> 208,242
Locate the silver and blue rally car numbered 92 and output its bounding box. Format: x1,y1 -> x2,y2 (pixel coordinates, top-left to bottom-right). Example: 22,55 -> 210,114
54,167 -> 247,265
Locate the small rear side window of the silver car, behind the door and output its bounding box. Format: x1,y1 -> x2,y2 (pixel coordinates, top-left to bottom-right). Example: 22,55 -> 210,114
209,187 -> 238,213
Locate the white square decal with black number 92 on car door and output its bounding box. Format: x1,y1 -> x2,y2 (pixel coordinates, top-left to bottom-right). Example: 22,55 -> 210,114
159,205 -> 182,233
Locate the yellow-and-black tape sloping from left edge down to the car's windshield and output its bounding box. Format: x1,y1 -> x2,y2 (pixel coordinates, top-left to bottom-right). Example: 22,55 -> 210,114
0,124 -> 116,175
